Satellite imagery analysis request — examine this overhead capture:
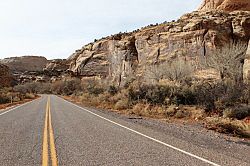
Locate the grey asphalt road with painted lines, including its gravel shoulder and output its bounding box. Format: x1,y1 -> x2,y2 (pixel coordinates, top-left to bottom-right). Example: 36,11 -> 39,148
0,95 -> 250,166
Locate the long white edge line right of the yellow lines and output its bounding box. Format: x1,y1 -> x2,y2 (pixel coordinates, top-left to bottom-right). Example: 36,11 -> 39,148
60,97 -> 220,166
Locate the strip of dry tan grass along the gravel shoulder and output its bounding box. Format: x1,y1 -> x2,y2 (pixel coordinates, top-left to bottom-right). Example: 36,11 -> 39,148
64,93 -> 250,138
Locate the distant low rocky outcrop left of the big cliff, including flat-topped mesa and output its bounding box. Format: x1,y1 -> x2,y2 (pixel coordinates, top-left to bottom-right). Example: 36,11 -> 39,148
0,56 -> 69,84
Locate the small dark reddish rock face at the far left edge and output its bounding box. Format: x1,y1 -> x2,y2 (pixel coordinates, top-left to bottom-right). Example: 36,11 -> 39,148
0,64 -> 13,87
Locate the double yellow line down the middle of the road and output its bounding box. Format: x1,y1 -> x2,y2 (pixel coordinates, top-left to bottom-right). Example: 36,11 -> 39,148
42,97 -> 58,166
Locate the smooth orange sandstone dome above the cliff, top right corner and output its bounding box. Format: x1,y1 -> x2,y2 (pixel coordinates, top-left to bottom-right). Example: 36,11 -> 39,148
199,0 -> 250,12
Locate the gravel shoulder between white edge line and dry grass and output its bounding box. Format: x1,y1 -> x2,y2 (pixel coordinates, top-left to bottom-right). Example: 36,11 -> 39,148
66,98 -> 250,163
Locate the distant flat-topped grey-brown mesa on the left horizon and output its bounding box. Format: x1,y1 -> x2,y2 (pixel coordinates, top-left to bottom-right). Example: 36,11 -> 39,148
0,56 -> 48,72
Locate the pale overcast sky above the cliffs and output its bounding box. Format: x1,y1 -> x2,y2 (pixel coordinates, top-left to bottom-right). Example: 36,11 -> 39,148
0,0 -> 201,59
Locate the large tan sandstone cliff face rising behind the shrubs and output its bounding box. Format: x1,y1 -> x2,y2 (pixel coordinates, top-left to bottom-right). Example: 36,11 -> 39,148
68,9 -> 250,84
